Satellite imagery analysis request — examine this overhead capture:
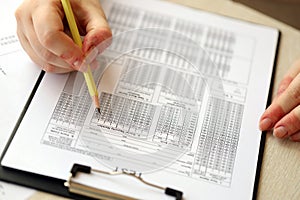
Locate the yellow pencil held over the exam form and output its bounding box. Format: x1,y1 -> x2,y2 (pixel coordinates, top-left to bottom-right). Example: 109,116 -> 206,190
61,0 -> 100,113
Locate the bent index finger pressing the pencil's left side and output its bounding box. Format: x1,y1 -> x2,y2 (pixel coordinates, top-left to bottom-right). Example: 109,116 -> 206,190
32,4 -> 83,69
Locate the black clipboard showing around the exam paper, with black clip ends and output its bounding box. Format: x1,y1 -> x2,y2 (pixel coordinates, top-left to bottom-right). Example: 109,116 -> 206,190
0,35 -> 280,200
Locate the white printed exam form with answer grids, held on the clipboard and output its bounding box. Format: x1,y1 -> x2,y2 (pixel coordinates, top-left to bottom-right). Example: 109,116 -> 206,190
2,0 -> 278,199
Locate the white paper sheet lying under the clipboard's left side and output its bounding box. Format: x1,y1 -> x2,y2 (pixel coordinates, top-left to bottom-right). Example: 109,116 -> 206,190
0,1 -> 40,200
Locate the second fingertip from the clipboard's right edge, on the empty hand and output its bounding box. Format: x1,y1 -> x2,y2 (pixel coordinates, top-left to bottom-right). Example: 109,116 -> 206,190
273,106 -> 300,138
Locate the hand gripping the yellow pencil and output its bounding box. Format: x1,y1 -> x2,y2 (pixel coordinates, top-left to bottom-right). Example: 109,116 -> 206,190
15,0 -> 111,73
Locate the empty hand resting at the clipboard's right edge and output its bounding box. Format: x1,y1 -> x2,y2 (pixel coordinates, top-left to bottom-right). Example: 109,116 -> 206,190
259,60 -> 300,142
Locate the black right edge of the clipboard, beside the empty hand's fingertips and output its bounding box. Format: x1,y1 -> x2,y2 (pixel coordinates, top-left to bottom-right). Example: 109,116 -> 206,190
252,29 -> 282,200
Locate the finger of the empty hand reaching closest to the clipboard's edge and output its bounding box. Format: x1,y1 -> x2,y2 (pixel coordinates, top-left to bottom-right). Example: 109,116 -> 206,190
259,72 -> 300,130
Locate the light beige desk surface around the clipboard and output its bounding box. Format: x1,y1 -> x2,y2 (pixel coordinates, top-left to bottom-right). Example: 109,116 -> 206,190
29,0 -> 300,200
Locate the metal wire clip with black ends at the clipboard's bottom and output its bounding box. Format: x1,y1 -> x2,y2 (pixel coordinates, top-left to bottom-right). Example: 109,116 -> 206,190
64,163 -> 183,200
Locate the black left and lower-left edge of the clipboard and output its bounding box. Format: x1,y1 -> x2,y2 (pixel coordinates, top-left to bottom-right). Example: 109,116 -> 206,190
0,71 -> 91,200
